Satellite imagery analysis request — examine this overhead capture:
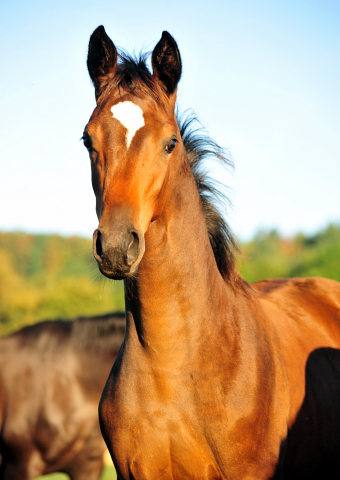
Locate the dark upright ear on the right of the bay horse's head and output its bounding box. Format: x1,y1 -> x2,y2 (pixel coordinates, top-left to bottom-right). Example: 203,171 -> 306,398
152,32 -> 182,95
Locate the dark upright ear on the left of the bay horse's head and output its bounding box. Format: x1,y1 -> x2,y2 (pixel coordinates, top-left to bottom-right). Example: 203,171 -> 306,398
87,25 -> 118,99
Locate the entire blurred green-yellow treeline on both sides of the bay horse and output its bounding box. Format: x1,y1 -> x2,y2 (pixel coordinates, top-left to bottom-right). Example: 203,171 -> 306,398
0,225 -> 340,335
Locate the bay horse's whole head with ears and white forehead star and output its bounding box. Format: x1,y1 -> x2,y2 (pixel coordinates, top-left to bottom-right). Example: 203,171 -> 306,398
83,26 -> 185,279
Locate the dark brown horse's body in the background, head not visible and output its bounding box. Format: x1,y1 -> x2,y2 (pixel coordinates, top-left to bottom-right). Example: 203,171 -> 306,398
0,314 -> 125,480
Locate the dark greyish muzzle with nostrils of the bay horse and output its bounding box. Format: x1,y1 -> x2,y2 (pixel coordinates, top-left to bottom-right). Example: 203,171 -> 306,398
93,227 -> 145,280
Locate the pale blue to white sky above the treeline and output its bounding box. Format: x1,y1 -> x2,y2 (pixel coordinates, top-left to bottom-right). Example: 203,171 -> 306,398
0,0 -> 340,240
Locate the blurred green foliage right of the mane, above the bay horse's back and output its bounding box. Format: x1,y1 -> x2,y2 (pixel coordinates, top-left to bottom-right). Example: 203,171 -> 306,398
240,225 -> 340,282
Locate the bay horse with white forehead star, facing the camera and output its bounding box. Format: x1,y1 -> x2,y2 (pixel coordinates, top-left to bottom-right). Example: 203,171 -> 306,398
83,26 -> 340,480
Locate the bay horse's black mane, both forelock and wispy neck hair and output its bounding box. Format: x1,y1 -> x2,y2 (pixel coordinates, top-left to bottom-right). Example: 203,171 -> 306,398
103,50 -> 248,290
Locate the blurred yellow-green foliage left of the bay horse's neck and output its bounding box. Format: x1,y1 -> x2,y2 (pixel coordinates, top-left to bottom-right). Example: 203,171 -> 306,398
0,232 -> 124,335
